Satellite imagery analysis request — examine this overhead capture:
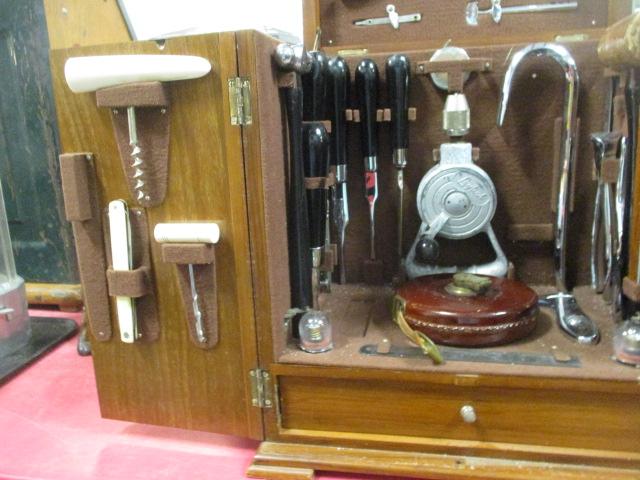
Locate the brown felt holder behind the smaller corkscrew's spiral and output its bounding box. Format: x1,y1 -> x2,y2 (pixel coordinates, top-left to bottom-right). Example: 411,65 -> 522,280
161,243 -> 218,349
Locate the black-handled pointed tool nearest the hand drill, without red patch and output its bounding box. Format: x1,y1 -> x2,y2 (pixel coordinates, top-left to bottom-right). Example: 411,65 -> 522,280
386,54 -> 411,272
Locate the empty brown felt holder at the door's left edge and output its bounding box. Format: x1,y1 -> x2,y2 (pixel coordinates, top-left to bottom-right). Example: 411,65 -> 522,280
60,153 -> 112,342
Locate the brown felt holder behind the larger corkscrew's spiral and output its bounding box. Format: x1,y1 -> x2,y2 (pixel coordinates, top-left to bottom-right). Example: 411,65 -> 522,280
96,82 -> 170,207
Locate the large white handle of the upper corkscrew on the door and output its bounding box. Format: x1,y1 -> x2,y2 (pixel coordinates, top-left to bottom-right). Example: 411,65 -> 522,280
64,55 -> 211,93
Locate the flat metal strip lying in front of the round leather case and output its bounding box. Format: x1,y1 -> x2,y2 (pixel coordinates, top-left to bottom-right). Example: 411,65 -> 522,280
360,345 -> 582,368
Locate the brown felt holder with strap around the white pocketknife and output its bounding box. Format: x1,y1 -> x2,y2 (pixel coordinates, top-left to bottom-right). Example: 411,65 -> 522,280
104,208 -> 160,343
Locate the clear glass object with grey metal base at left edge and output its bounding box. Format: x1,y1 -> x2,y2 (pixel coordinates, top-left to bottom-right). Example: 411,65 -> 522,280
0,184 -> 31,357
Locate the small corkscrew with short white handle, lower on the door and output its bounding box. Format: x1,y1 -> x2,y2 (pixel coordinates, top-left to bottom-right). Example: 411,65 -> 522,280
153,222 -> 220,343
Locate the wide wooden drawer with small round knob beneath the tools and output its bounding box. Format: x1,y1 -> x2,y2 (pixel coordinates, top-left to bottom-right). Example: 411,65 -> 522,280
277,369 -> 640,453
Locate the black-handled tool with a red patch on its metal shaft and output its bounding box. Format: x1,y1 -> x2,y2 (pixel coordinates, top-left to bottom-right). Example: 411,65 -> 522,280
355,58 -> 378,260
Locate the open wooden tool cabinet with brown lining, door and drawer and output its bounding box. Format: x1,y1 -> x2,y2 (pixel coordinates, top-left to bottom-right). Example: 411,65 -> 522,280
52,0 -> 640,479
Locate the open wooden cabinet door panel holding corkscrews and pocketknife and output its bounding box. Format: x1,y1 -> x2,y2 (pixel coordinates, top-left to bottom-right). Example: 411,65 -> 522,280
47,33 -> 262,438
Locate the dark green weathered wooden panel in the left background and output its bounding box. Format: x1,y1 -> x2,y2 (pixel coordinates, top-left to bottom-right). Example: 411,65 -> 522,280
0,0 -> 77,283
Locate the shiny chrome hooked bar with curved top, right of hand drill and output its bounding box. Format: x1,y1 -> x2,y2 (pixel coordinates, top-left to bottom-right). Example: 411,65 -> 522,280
497,43 -> 600,343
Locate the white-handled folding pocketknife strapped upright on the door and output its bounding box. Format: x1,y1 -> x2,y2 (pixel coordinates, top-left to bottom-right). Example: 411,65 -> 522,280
109,200 -> 139,343
